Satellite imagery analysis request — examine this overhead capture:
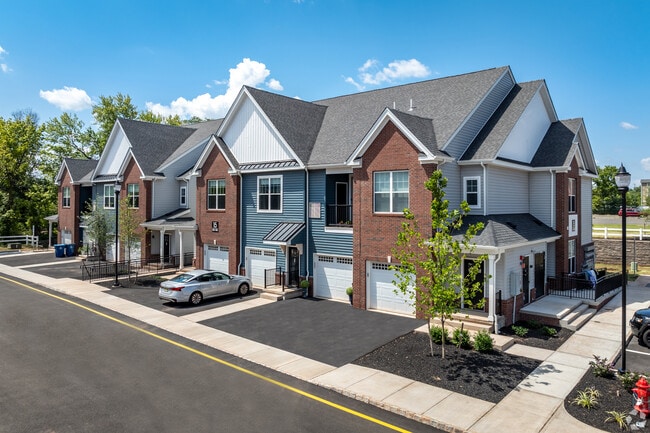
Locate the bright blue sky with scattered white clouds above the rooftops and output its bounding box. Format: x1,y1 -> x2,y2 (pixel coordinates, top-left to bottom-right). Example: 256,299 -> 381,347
0,0 -> 650,184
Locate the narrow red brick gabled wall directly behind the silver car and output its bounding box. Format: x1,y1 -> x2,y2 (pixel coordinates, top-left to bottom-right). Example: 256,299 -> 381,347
196,147 -> 240,274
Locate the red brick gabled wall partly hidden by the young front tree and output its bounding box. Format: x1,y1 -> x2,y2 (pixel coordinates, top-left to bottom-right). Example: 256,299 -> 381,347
352,122 -> 436,309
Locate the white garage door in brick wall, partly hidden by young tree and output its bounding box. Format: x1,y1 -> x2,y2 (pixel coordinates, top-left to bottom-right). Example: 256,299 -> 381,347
366,262 -> 415,314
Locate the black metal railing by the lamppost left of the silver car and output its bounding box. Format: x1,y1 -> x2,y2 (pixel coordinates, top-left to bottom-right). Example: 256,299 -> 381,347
80,253 -> 194,282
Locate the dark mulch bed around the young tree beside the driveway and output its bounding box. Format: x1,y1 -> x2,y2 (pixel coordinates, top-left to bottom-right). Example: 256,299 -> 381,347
354,332 -> 540,403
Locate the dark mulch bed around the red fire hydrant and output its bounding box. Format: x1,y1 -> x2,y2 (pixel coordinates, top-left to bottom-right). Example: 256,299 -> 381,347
564,370 -> 650,432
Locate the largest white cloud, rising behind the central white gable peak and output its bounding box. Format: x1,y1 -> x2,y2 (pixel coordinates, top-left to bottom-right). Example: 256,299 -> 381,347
146,59 -> 283,119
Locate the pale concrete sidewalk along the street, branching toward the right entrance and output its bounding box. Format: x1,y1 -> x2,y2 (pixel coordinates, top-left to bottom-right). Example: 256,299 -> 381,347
0,258 -> 650,433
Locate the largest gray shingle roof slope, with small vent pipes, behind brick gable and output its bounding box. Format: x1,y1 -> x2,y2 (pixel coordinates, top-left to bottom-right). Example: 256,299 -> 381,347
309,67 -> 509,165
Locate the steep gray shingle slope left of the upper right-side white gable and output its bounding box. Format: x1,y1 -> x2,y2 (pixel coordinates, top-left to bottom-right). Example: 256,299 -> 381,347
460,80 -> 544,162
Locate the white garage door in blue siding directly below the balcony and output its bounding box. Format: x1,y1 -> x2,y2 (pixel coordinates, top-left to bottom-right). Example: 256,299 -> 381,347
314,254 -> 352,301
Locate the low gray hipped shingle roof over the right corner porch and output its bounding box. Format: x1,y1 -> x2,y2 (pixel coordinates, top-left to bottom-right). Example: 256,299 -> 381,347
455,214 -> 560,248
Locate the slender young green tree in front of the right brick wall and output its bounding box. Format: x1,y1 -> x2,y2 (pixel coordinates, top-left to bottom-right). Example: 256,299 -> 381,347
392,170 -> 486,358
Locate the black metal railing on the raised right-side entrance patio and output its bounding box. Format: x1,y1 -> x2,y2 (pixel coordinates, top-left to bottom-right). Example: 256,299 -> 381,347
548,270 -> 623,301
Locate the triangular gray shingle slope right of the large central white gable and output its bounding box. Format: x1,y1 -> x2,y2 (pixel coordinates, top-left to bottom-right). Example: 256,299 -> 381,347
246,86 -> 326,164
